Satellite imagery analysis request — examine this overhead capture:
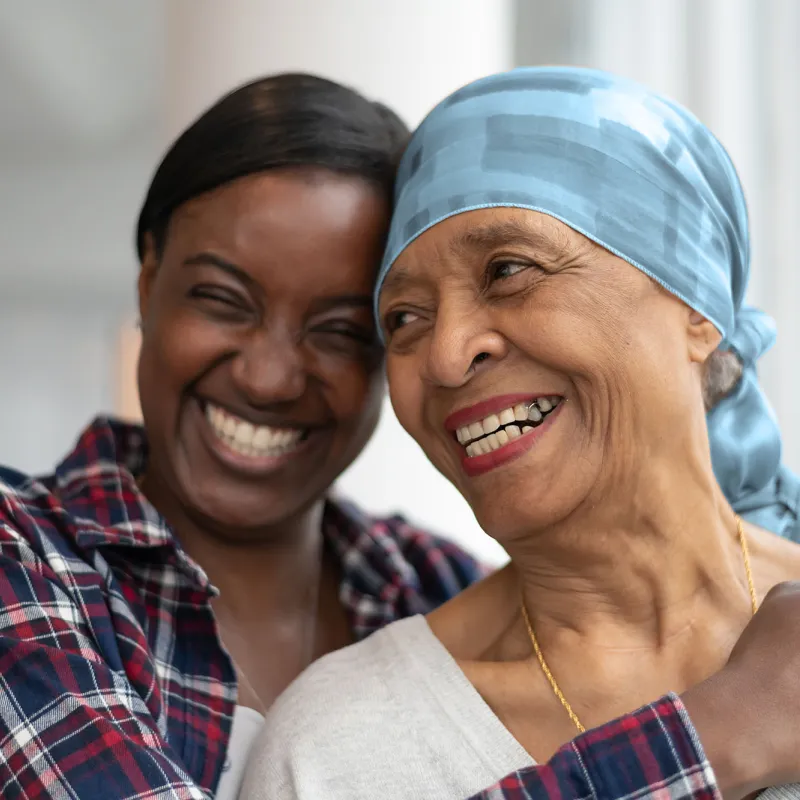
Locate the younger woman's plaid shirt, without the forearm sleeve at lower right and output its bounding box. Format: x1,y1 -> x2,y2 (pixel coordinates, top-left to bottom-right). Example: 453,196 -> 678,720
0,419 -> 481,800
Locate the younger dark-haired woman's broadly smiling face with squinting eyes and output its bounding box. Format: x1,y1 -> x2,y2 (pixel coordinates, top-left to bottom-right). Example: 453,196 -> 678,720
139,170 -> 388,531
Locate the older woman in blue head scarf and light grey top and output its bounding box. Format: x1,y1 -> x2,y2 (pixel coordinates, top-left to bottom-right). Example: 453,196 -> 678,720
245,68 -> 800,800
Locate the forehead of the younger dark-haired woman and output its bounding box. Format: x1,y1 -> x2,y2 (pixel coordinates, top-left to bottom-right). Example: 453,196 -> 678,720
165,170 -> 388,291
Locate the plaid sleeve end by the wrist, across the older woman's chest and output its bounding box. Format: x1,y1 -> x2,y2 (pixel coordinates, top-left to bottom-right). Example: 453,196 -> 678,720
470,694 -> 722,800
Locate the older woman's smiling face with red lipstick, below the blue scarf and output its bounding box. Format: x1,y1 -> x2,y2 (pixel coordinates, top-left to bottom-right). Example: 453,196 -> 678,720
380,208 -> 716,542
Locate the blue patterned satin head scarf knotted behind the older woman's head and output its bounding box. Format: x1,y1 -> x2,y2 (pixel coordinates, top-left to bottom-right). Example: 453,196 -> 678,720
375,67 -> 800,539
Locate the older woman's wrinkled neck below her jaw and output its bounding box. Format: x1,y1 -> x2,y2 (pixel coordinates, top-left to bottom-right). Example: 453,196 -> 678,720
508,454 -> 750,648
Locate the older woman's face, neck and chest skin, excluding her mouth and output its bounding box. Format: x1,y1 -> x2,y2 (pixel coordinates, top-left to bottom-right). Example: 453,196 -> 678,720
380,208 -> 800,772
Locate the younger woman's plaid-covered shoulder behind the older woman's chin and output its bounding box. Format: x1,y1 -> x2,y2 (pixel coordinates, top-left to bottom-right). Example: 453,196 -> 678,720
328,499 -> 489,612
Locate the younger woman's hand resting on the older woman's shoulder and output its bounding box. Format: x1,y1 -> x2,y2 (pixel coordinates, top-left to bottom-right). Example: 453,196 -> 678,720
682,583 -> 800,800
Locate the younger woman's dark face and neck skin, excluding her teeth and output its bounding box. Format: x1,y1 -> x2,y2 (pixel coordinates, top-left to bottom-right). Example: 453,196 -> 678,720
139,169 -> 388,708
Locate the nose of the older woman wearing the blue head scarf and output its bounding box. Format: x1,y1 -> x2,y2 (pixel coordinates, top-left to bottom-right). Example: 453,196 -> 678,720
423,300 -> 508,388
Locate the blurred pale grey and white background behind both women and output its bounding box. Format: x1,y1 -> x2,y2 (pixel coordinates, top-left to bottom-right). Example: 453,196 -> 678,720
0,0 -> 800,560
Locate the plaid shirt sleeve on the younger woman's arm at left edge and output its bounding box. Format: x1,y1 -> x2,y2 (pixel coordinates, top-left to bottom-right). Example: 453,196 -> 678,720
0,521 -> 207,800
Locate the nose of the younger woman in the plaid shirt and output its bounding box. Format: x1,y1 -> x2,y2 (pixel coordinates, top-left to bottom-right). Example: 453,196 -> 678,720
232,327 -> 307,406
